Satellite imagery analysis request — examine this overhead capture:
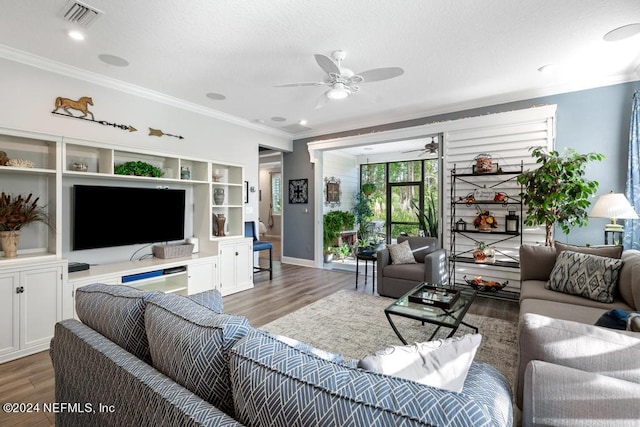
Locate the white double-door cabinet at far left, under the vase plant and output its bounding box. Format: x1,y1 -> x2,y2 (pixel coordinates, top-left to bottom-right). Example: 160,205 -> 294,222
0,262 -> 66,363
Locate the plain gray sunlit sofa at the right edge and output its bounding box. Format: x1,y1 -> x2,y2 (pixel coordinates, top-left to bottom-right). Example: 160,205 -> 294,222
516,242 -> 640,426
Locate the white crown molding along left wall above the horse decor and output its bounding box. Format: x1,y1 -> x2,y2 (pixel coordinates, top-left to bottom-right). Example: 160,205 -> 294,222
0,45 -> 292,139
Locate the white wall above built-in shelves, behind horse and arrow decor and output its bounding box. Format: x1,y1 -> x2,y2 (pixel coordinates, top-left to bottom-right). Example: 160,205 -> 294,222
0,58 -> 292,264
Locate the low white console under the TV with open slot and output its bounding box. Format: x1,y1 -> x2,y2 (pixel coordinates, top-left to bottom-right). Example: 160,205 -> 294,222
63,252 -> 218,318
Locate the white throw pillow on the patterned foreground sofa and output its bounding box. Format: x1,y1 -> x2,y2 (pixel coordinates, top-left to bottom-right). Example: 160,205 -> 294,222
358,334 -> 482,392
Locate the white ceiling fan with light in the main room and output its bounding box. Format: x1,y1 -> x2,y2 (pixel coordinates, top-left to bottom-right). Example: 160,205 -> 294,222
275,50 -> 404,108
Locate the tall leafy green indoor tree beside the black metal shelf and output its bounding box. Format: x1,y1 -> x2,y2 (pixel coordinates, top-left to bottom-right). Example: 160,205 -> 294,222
517,146 -> 604,246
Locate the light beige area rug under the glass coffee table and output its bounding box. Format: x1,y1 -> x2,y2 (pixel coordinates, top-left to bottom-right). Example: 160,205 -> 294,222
261,290 -> 517,388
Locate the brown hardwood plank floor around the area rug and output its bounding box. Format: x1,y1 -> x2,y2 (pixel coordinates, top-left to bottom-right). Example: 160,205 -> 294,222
0,259 -> 518,426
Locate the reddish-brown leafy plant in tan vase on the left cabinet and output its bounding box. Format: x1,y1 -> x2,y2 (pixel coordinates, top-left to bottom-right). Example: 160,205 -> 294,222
0,192 -> 49,258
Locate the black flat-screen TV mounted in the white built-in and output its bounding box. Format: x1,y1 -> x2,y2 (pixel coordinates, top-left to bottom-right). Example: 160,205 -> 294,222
71,185 -> 185,250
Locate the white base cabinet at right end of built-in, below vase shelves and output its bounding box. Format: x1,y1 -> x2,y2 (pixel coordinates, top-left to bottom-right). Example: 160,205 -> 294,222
218,238 -> 253,295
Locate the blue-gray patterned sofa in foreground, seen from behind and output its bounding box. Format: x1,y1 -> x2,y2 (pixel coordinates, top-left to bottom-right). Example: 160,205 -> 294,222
51,284 -> 512,427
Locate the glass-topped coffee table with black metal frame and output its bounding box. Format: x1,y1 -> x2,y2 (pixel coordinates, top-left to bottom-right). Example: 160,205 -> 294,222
384,282 -> 478,344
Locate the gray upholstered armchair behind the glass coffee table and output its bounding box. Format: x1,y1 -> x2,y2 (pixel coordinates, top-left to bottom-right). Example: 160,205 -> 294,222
377,236 -> 448,298
